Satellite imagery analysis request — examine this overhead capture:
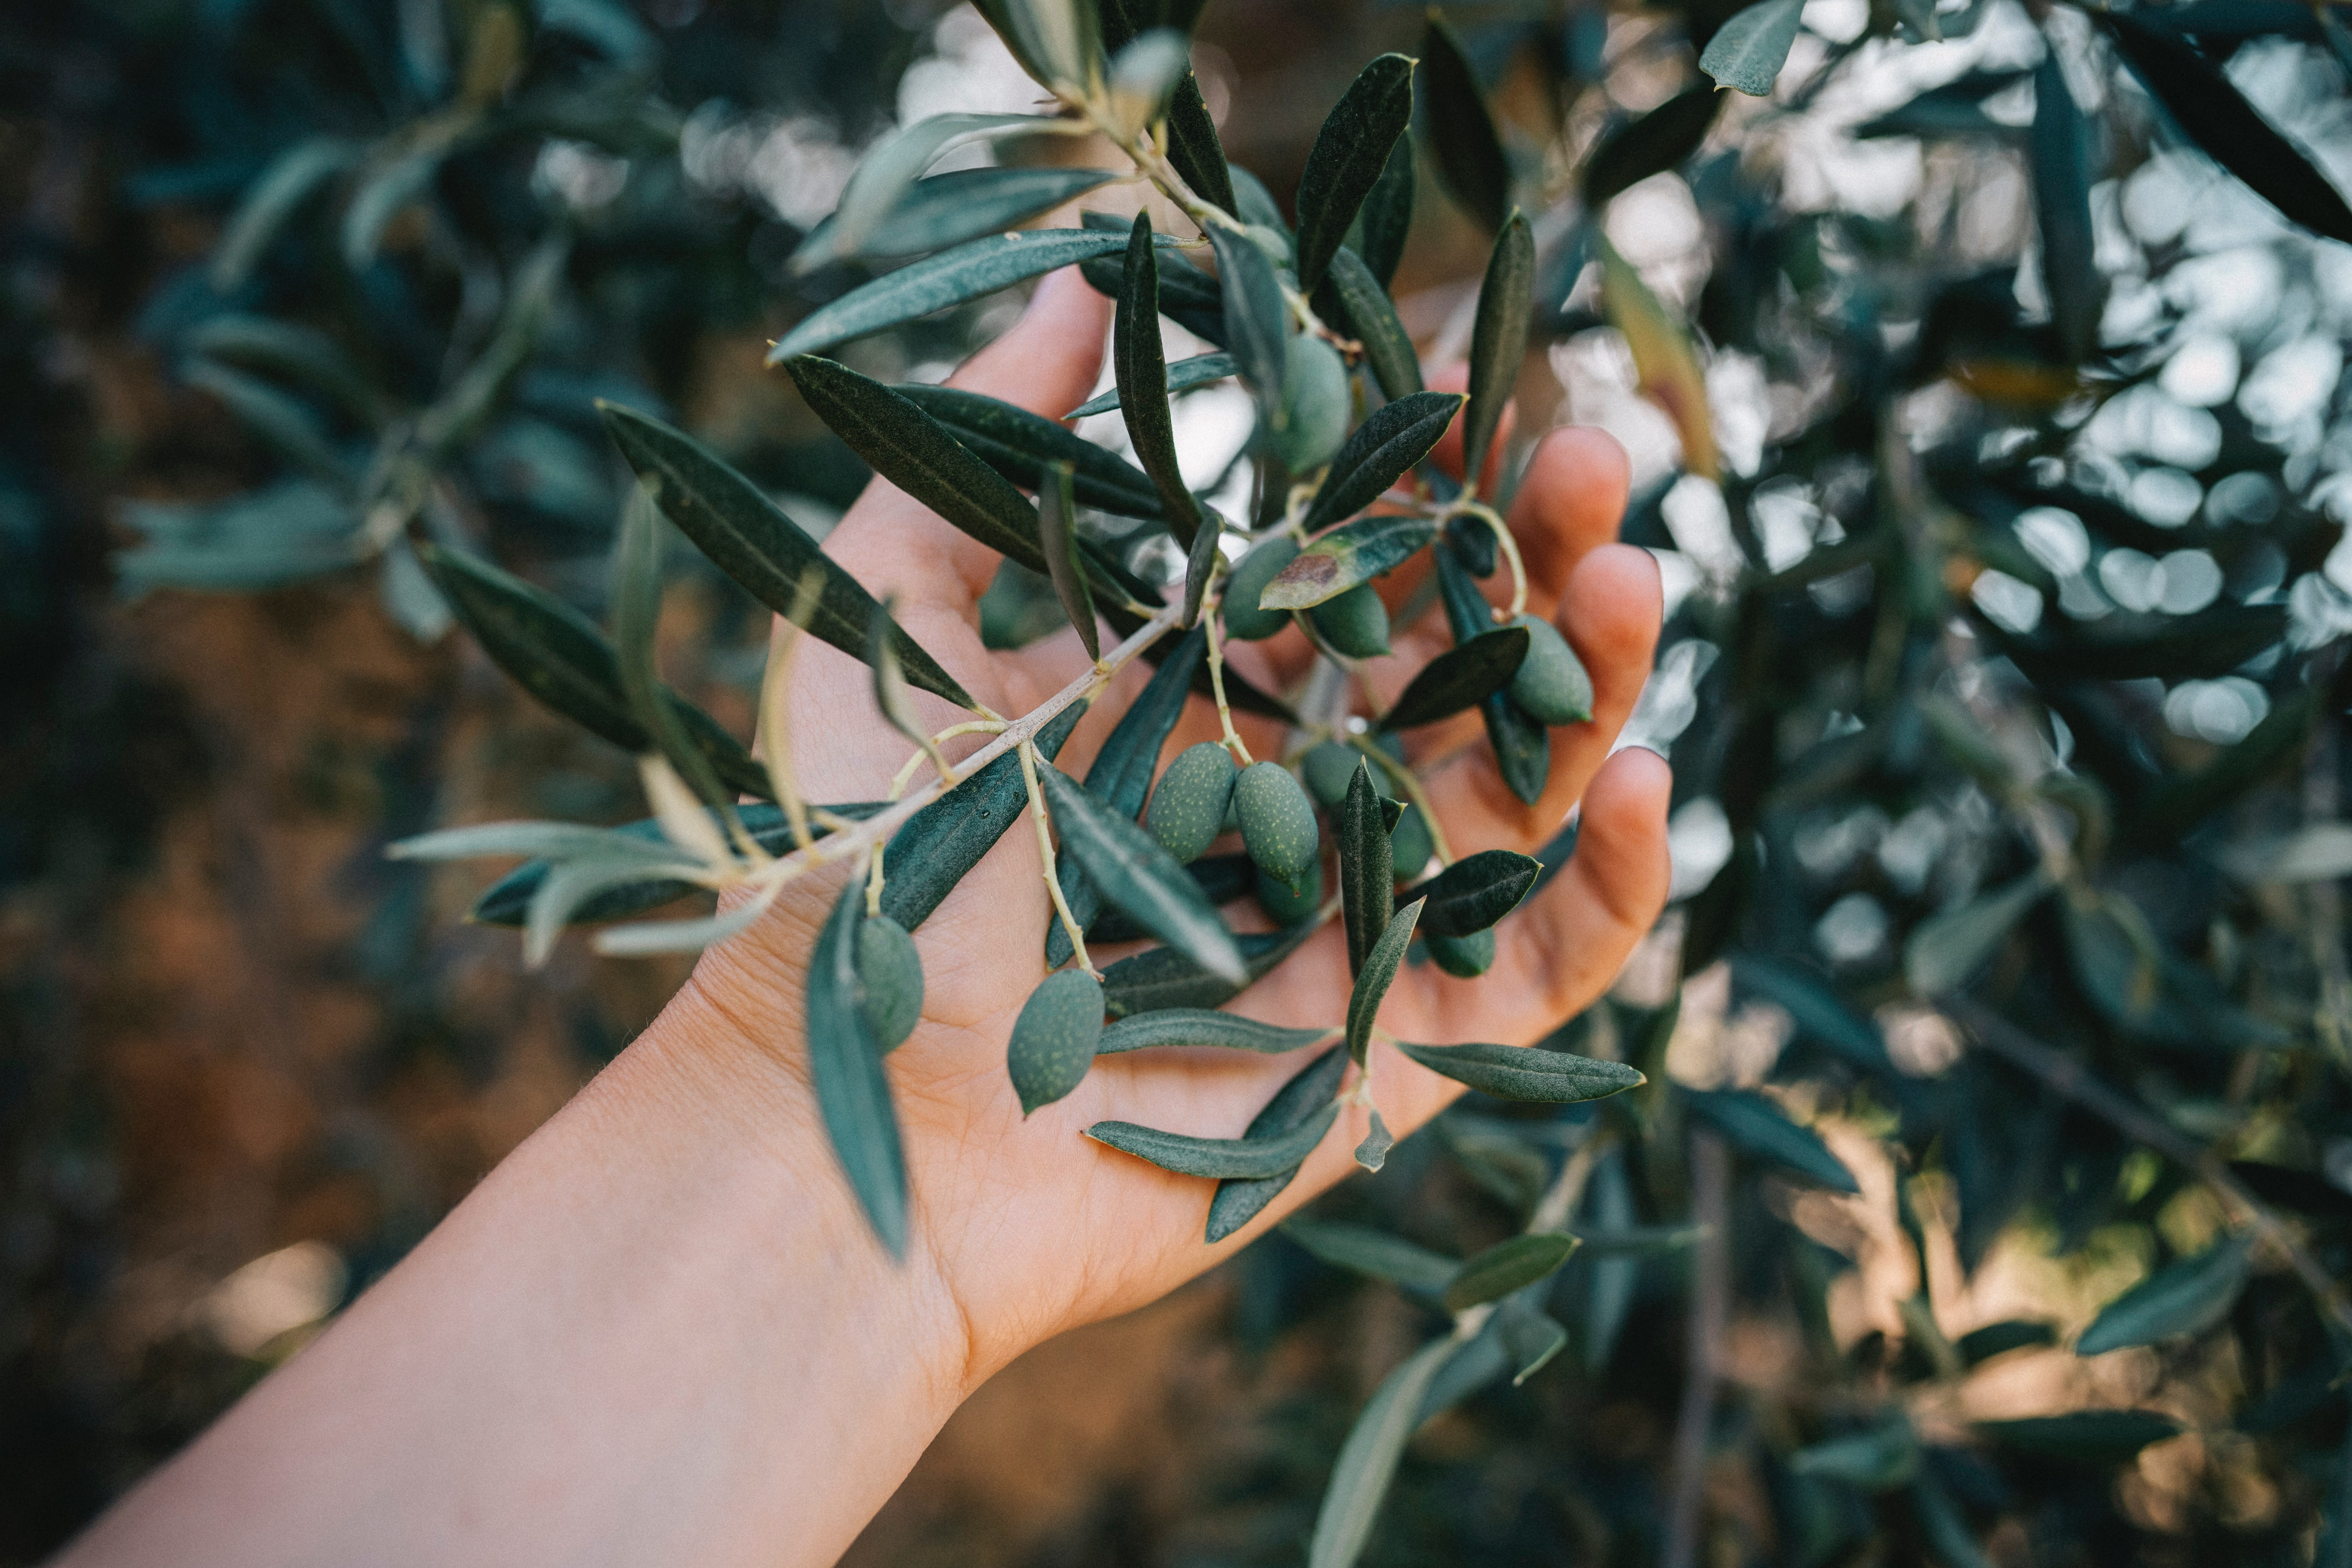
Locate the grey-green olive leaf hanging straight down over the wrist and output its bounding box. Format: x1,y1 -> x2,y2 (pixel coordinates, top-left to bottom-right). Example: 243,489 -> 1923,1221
809,877 -> 908,1258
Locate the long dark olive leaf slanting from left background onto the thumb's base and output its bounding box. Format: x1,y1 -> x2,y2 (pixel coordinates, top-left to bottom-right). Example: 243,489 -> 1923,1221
597,402 -> 976,710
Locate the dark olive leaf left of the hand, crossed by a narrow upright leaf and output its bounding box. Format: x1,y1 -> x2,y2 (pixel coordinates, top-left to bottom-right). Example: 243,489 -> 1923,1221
416,543 -> 774,797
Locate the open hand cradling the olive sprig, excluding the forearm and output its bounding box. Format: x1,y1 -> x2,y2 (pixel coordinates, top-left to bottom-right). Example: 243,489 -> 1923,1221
668,273 -> 1670,1389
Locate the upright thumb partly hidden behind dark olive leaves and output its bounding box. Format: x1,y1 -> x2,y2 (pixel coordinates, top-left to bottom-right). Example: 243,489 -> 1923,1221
825,268 -> 1110,616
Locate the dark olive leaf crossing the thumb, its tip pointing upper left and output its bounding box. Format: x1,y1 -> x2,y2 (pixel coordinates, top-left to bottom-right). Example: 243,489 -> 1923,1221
786,357 -> 1044,576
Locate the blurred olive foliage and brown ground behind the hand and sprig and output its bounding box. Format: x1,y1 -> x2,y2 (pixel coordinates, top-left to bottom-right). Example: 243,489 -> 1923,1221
14,0 -> 2352,1568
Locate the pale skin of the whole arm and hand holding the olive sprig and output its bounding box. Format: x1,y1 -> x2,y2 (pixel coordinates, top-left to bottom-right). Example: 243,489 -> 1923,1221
59,275 -> 1670,1568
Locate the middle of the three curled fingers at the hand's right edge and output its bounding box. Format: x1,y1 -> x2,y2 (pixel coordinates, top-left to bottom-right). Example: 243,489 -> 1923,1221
1409,545 -> 1663,849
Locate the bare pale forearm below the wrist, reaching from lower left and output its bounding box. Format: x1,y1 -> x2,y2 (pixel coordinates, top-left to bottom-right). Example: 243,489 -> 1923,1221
63,987 -> 964,1568
